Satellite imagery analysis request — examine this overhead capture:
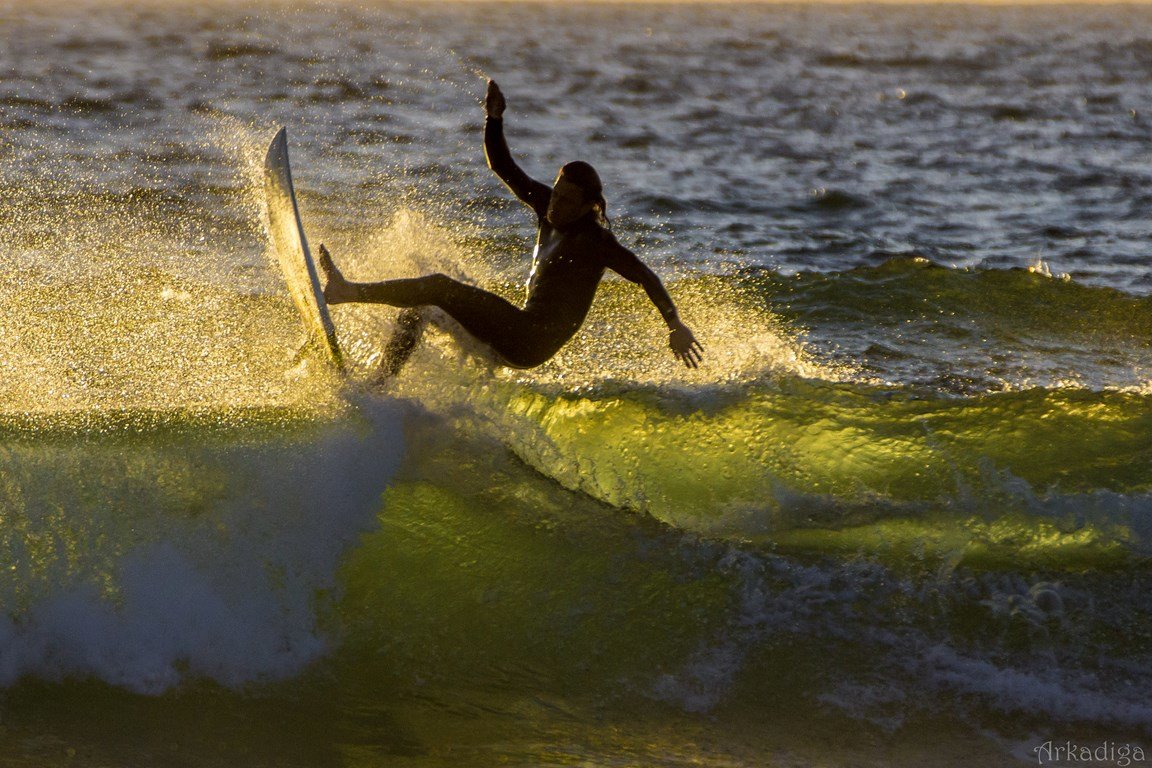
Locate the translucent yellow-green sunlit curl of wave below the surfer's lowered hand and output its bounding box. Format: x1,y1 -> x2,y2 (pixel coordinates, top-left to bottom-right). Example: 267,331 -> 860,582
428,363 -> 1152,568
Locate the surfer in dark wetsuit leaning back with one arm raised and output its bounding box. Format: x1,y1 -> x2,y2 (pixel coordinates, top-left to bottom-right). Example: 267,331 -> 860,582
320,81 -> 704,373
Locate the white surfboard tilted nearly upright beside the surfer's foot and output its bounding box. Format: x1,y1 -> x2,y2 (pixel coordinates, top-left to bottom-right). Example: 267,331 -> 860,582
264,128 -> 343,367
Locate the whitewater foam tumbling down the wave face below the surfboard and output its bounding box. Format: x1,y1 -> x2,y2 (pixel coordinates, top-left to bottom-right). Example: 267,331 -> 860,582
0,393 -> 401,693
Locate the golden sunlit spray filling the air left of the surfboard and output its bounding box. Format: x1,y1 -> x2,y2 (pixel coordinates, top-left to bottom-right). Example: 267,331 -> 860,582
0,138 -> 339,420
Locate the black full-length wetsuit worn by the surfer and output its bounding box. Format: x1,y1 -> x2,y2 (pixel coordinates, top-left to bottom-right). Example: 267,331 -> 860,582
357,117 -> 676,368
